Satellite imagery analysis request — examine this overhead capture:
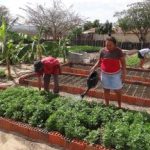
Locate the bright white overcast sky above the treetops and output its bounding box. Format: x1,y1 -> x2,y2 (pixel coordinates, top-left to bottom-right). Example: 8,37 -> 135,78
0,0 -> 142,23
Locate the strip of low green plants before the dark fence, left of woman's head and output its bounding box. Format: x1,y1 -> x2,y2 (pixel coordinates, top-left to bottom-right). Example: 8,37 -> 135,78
68,45 -> 101,52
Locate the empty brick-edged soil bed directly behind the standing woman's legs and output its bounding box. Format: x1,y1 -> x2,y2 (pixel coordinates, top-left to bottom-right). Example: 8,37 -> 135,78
19,74 -> 150,107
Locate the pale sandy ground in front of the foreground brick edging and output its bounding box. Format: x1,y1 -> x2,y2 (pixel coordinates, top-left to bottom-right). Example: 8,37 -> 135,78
0,130 -> 60,150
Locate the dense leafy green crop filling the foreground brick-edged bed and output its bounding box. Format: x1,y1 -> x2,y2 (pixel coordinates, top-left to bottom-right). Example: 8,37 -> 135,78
0,87 -> 150,150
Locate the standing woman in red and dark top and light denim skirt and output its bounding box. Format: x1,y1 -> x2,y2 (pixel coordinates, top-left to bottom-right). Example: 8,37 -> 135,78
91,37 -> 126,108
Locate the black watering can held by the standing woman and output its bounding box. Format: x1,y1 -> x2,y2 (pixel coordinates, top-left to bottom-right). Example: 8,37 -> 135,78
81,71 -> 99,98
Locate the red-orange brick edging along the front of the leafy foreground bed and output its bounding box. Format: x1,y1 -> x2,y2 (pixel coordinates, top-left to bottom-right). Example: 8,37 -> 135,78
0,117 -> 109,150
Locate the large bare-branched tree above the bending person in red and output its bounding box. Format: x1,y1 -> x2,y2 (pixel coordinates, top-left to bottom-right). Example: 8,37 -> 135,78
23,0 -> 82,40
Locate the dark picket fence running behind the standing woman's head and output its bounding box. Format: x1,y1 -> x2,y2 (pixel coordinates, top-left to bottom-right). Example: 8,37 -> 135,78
71,40 -> 150,50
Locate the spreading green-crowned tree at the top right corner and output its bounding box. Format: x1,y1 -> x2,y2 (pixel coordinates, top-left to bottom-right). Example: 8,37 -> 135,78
115,0 -> 150,42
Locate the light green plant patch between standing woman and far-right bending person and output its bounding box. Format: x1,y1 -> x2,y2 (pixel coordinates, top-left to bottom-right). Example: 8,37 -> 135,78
126,54 -> 140,67
